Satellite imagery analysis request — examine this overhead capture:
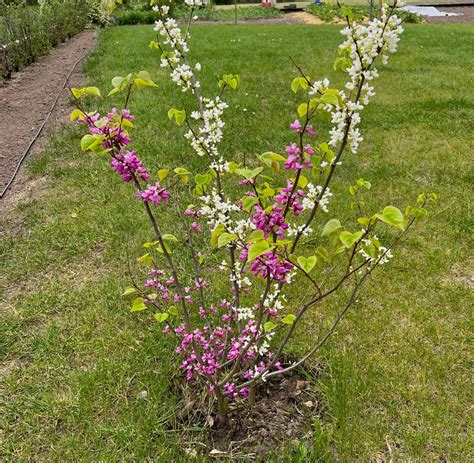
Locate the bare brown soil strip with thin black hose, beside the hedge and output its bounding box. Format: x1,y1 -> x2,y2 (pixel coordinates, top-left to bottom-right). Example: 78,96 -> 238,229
0,30 -> 98,201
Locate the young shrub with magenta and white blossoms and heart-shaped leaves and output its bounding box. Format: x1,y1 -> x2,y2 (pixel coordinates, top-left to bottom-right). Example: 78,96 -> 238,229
71,0 -> 436,416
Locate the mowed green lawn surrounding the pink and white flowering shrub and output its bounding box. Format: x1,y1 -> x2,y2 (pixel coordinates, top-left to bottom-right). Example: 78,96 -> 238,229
0,25 -> 474,462
